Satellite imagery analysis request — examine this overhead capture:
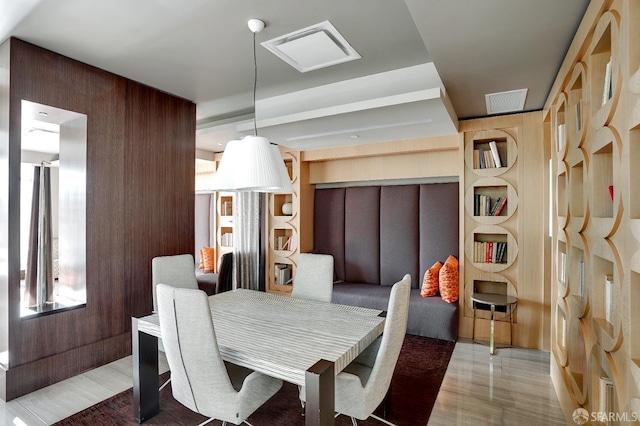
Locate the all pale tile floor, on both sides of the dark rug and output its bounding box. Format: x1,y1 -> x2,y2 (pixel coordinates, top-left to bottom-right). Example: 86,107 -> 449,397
0,340 -> 565,426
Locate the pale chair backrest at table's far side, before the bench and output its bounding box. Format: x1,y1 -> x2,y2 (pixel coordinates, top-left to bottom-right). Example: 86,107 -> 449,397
291,253 -> 333,302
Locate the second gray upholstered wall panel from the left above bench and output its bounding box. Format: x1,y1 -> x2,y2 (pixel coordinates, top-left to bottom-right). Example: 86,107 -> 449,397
344,186 -> 380,284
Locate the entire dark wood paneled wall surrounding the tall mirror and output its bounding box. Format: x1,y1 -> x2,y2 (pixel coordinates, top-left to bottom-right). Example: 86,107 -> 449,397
0,39 -> 195,397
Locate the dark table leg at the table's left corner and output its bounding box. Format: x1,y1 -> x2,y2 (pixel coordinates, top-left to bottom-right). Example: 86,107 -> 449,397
131,318 -> 160,423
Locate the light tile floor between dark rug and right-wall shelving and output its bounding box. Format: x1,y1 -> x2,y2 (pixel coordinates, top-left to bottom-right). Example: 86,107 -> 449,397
428,339 -> 566,426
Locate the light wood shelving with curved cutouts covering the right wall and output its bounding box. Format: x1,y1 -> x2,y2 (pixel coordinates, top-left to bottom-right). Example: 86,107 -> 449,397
545,0 -> 640,424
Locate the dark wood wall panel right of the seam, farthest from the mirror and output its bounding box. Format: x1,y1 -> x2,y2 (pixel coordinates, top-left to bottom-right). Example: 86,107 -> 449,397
125,83 -> 195,316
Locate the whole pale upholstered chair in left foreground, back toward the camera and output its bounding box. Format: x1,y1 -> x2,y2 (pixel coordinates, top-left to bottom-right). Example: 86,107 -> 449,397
156,284 -> 282,425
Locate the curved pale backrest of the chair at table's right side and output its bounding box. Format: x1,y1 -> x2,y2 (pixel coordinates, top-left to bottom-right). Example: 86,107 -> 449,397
365,274 -> 411,406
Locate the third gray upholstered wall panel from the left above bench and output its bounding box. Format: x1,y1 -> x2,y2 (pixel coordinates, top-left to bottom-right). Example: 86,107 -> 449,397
380,185 -> 420,288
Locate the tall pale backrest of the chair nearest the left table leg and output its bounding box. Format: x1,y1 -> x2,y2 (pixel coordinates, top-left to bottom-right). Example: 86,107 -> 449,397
157,284 -> 236,418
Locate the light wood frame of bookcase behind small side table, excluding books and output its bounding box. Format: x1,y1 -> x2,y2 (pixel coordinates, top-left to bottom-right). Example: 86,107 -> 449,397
460,121 -> 528,346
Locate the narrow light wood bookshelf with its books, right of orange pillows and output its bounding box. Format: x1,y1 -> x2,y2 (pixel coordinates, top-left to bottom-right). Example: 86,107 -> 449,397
464,123 -> 532,345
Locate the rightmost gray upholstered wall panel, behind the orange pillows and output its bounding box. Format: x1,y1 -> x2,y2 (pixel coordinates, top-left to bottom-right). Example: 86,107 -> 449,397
420,182 -> 460,273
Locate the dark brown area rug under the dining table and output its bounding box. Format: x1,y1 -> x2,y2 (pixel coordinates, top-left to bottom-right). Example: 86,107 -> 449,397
56,335 -> 455,426
